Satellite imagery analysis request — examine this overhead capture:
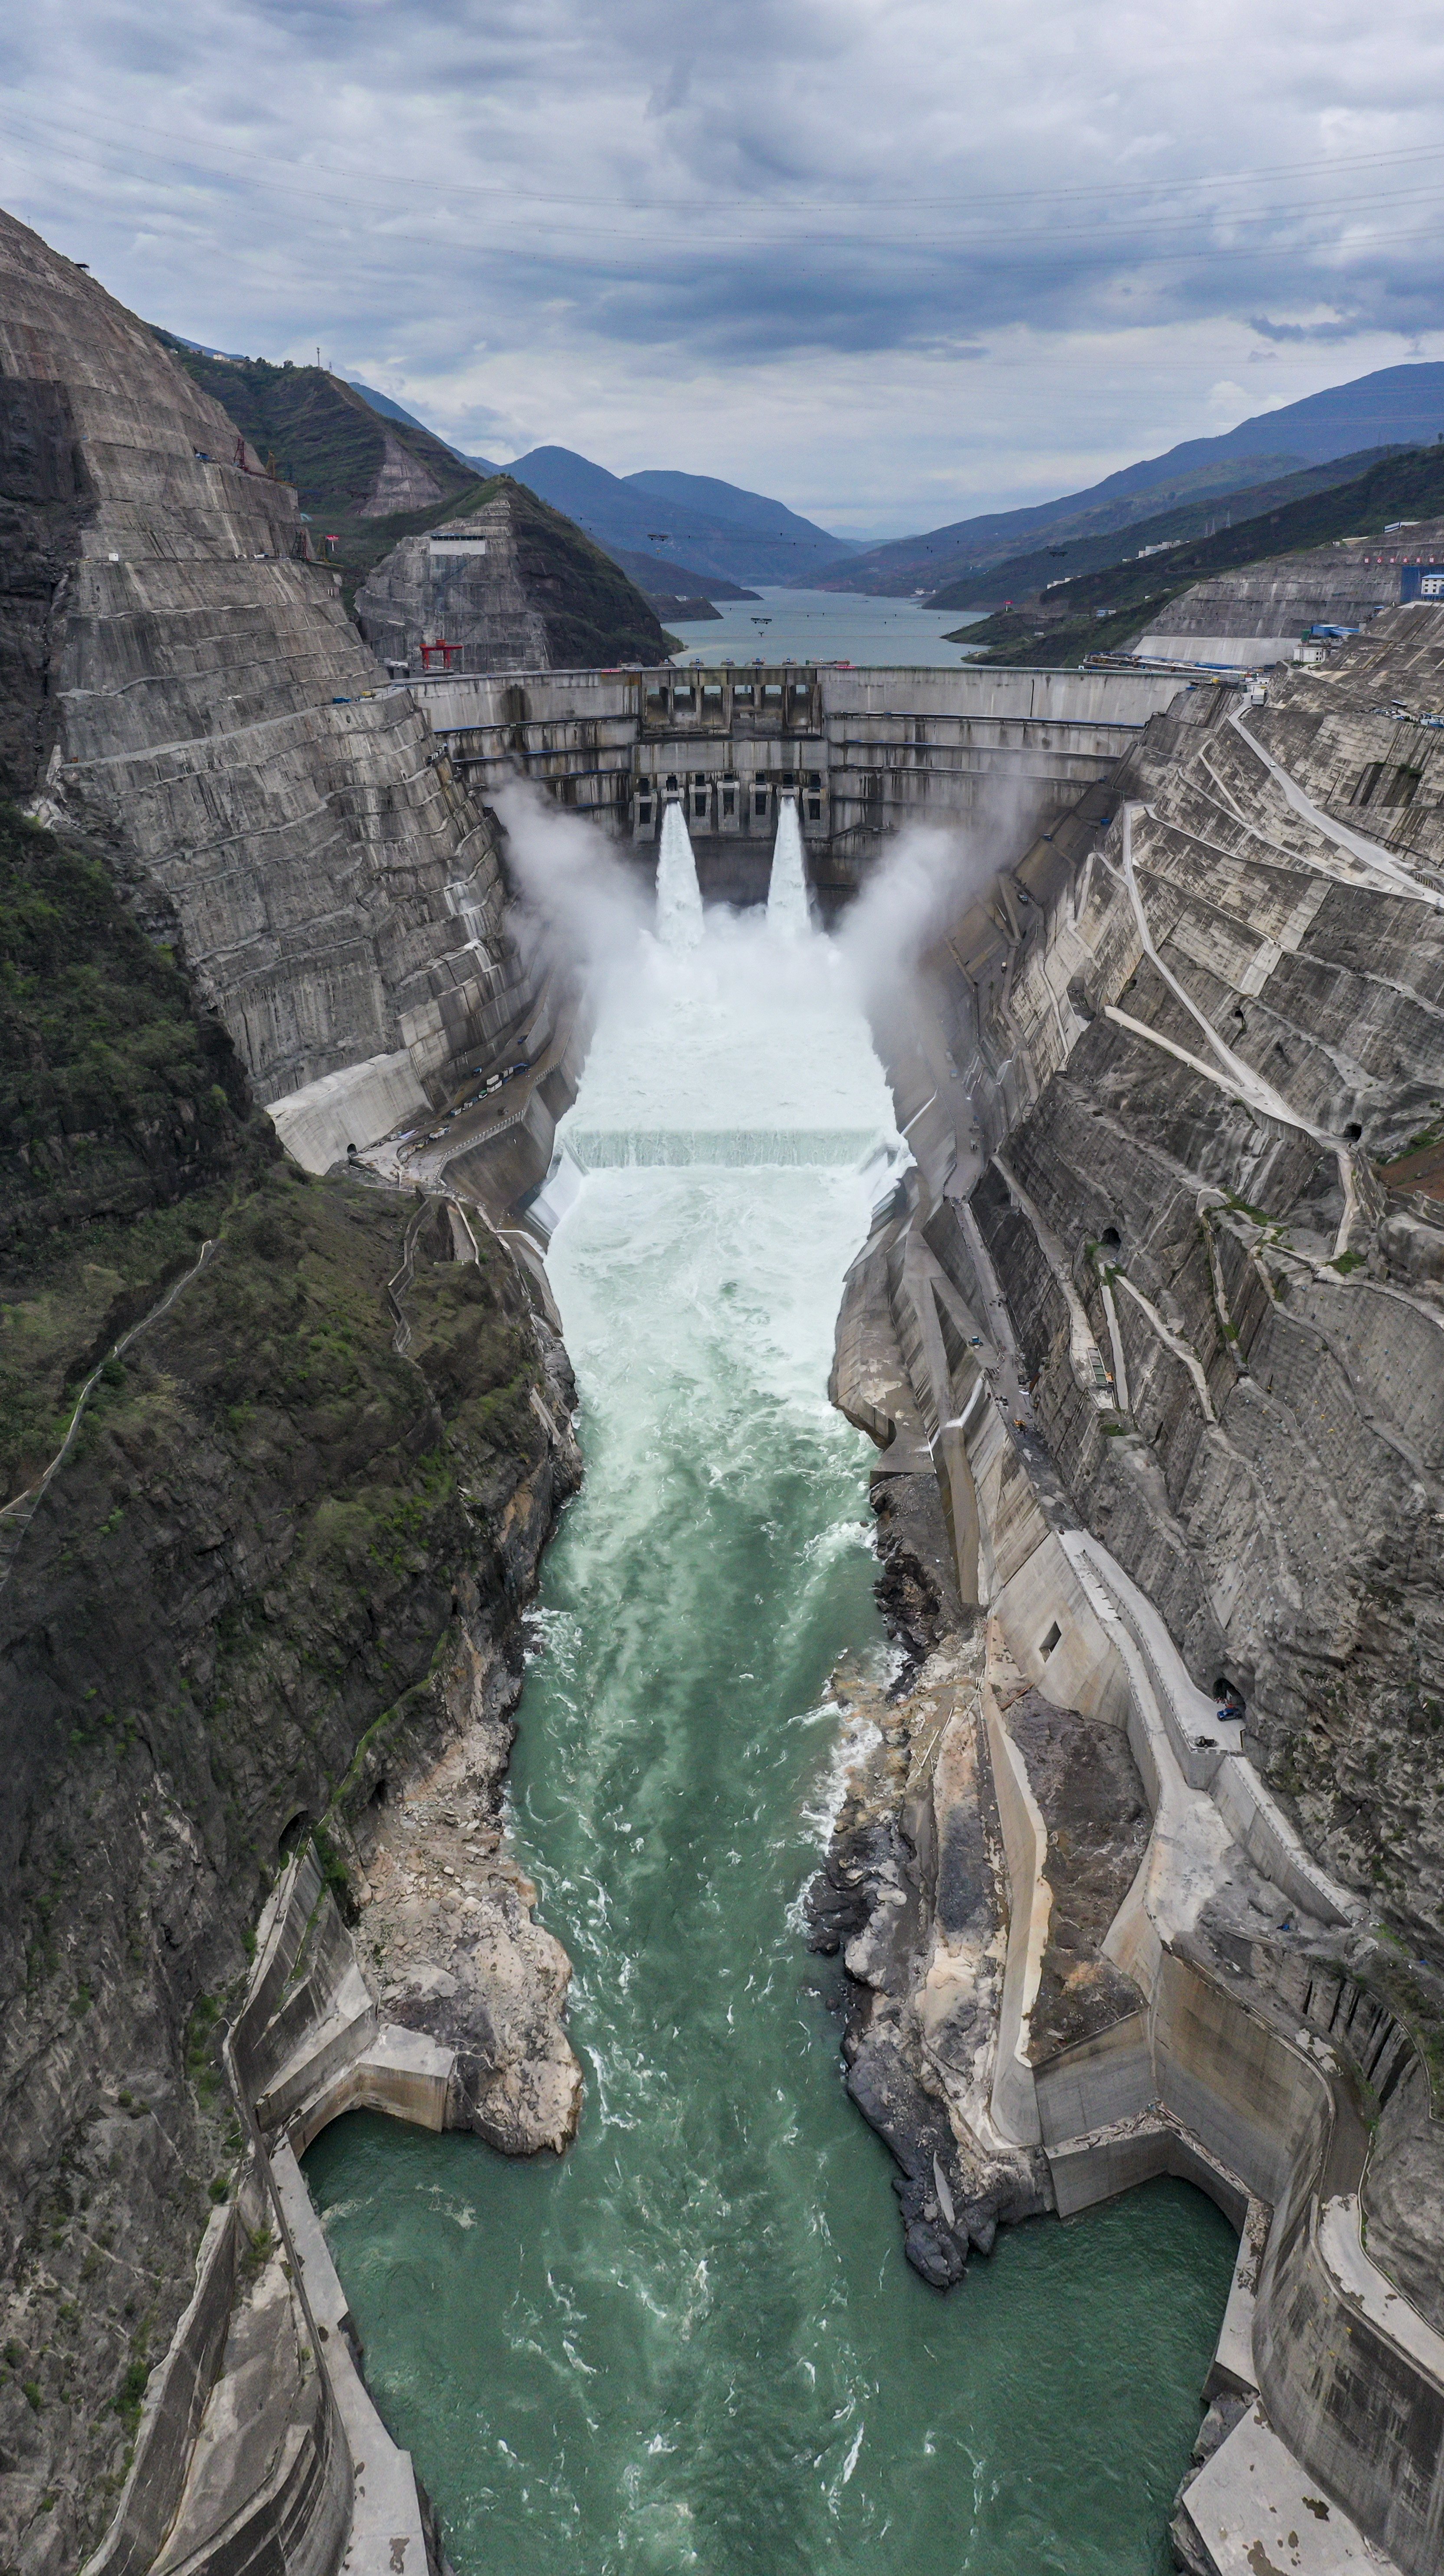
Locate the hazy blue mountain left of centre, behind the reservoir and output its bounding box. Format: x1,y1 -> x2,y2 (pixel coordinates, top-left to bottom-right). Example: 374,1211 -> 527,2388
495,448 -> 856,582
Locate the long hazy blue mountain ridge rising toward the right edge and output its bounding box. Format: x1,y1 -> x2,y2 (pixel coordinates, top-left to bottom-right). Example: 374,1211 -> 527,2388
820,361 -> 1444,598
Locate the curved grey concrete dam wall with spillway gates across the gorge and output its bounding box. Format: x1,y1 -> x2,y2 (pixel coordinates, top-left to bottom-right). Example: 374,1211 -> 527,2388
410,662 -> 1176,909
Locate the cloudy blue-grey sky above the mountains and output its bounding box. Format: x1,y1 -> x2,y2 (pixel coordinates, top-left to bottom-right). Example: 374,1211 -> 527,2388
0,0 -> 1444,536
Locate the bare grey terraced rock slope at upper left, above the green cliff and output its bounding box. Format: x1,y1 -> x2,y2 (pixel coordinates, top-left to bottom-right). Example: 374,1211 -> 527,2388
0,216 -> 521,1100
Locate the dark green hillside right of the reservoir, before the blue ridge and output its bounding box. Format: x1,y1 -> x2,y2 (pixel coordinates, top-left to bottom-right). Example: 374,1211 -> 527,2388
949,440 -> 1444,670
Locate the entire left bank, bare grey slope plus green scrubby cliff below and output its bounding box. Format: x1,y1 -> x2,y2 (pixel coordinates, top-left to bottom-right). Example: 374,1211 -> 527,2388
0,216 -> 593,2576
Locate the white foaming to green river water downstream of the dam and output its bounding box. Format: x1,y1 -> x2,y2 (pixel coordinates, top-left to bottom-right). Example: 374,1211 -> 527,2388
307,819 -> 1233,2576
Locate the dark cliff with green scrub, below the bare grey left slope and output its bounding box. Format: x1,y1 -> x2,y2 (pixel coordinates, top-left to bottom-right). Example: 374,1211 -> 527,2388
0,793 -> 578,2568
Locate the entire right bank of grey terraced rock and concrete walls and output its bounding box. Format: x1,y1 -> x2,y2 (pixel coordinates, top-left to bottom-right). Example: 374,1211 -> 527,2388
835,608 -> 1444,2576
